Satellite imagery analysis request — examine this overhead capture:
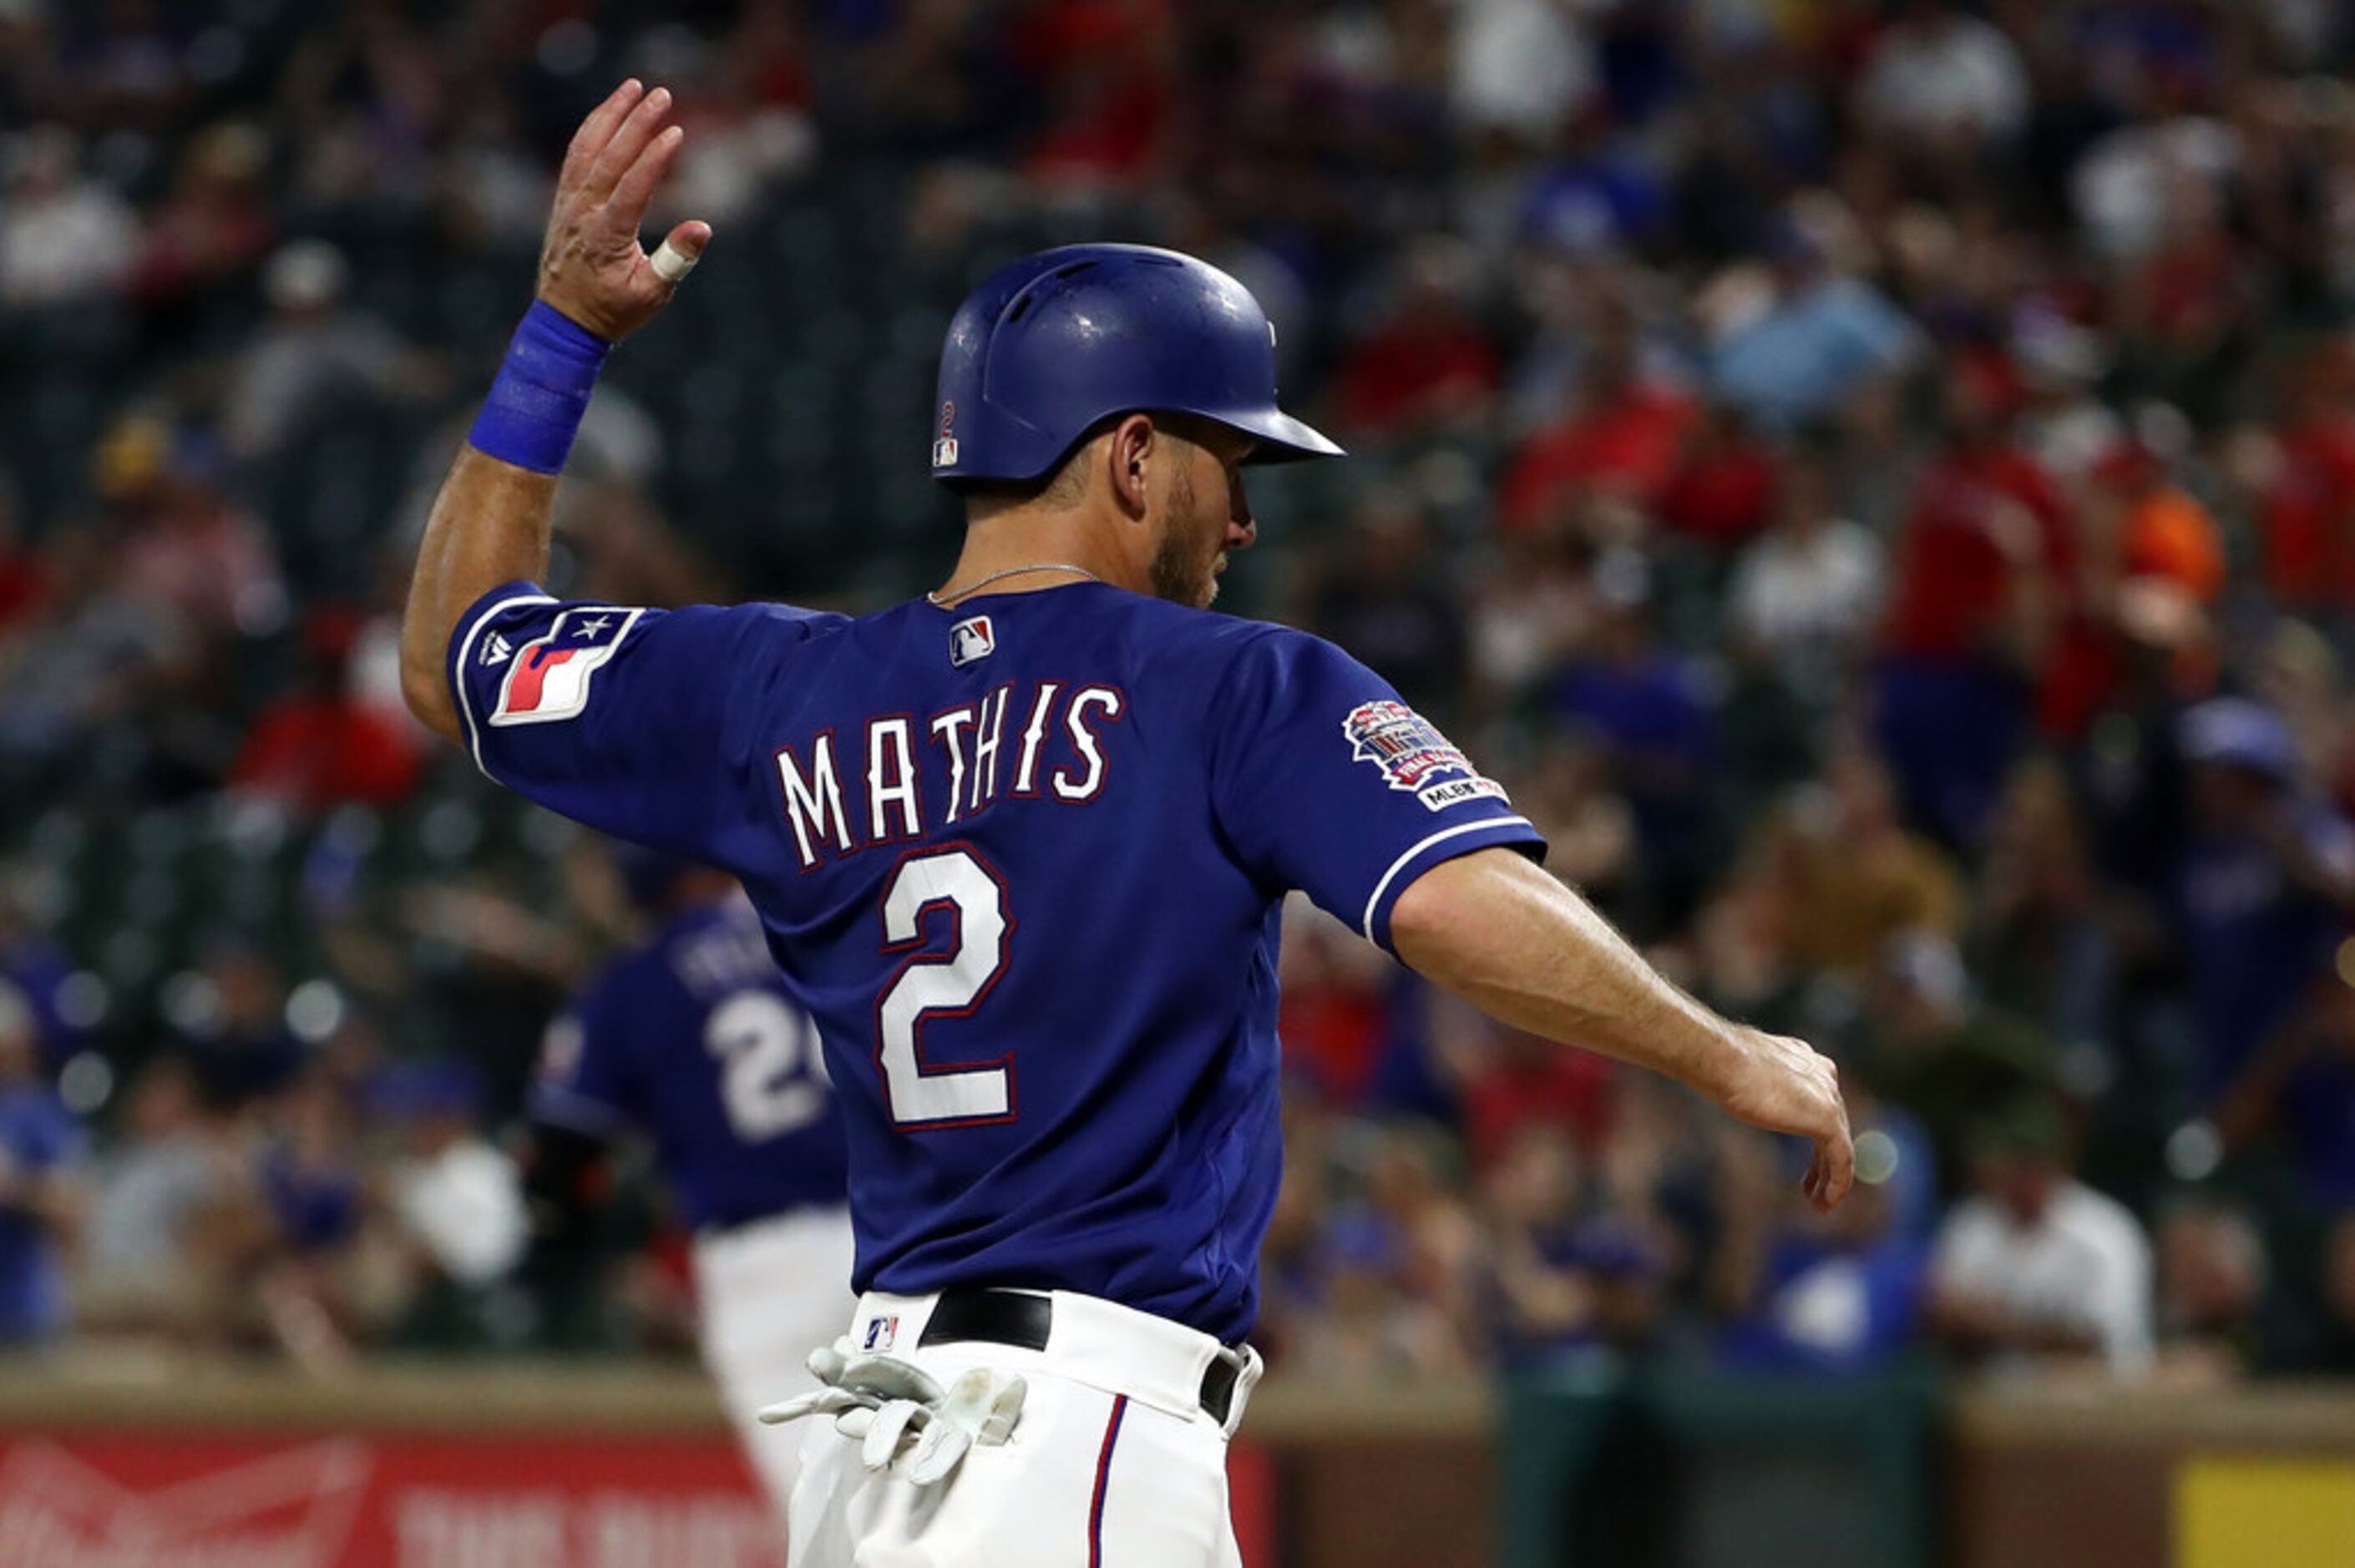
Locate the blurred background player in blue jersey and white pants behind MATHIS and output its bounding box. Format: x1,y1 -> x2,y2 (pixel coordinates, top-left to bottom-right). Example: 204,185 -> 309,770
528,850 -> 850,1514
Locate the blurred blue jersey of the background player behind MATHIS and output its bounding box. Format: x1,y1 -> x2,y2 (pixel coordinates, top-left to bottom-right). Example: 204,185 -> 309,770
530,899 -> 848,1227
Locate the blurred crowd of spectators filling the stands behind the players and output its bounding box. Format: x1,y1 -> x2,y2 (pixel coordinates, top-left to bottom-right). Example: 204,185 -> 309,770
0,0 -> 2355,1387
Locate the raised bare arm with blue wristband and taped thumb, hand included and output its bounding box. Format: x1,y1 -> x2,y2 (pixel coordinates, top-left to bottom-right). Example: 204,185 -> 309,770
400,80 -> 712,739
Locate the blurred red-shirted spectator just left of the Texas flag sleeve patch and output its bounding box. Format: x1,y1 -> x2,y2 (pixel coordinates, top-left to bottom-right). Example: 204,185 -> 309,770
229,608 -> 424,812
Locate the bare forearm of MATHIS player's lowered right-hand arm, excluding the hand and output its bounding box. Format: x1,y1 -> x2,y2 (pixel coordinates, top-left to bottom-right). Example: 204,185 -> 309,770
1390,850 -> 1745,1097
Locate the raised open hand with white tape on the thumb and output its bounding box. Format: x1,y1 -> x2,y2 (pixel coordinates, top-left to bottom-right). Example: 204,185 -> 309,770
539,80 -> 712,341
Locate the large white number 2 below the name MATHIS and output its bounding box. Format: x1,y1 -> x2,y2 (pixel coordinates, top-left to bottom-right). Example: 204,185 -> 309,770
876,850 -> 1013,1128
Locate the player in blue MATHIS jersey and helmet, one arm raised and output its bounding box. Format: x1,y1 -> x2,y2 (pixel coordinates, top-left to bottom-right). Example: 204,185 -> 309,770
403,83 -> 1853,1568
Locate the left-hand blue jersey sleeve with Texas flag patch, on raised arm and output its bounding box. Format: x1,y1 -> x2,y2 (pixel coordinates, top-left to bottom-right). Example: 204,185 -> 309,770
450,581 -> 841,864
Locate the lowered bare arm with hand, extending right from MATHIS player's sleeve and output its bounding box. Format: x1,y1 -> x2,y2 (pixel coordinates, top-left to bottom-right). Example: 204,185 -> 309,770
1390,850 -> 1856,1208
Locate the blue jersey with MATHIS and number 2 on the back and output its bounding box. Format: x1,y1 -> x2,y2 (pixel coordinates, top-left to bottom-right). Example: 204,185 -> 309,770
450,584 -> 1542,1339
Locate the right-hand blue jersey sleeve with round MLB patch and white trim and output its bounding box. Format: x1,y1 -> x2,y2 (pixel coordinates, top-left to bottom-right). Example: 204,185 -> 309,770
1210,631 -> 1545,948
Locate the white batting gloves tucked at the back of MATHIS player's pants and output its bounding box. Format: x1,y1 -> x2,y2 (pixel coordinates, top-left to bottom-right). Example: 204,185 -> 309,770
761,1339 -> 1029,1485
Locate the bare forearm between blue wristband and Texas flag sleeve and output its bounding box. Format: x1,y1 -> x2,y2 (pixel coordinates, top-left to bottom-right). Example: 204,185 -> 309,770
400,445 -> 556,739
